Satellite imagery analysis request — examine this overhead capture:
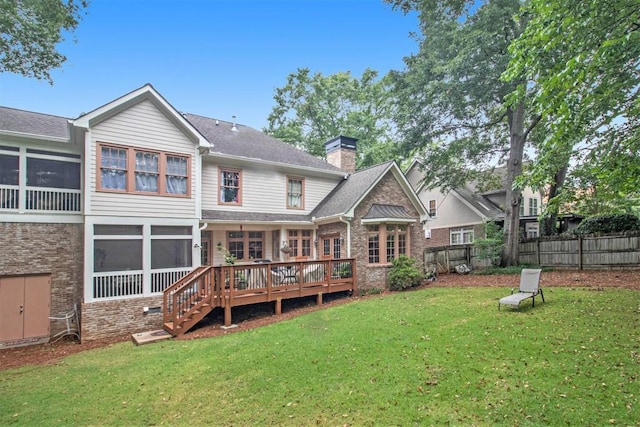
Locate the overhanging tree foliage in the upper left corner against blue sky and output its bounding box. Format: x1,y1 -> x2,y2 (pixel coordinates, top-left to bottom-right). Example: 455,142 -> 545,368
0,0 -> 88,84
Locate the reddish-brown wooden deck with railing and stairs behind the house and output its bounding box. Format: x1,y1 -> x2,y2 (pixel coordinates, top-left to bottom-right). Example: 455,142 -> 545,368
163,258 -> 356,336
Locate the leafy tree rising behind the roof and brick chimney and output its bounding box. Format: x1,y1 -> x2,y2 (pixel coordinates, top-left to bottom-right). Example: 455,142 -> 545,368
265,68 -> 396,167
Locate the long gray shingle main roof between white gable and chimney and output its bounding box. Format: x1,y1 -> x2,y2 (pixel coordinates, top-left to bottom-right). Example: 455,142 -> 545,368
183,114 -> 342,172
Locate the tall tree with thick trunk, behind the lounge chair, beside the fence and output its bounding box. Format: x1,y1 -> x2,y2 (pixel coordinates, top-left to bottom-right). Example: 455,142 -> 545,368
386,0 -> 540,265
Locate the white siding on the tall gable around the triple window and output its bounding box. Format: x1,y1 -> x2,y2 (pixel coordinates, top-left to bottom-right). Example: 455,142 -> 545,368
87,101 -> 200,218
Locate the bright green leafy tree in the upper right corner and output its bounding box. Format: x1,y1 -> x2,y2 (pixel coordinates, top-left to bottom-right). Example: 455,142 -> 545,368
504,0 -> 640,213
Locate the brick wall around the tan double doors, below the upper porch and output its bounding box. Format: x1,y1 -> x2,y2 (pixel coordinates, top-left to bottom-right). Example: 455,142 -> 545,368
0,222 -> 84,335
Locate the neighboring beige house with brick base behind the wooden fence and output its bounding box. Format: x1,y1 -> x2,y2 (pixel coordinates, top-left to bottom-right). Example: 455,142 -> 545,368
405,160 -> 542,247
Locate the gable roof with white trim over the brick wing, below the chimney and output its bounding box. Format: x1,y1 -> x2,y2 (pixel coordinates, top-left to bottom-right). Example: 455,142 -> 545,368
311,160 -> 428,221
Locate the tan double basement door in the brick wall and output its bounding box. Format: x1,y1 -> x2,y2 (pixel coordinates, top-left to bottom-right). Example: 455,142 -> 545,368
0,275 -> 51,348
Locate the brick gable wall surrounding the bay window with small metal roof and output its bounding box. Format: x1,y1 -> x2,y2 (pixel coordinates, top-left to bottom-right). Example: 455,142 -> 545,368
351,173 -> 427,290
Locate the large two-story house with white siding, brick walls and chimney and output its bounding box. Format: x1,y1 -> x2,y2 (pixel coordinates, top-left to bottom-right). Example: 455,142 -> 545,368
0,85 -> 428,347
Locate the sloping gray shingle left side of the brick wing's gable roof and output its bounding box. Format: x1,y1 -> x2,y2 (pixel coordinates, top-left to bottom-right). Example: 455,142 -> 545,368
311,160 -> 393,218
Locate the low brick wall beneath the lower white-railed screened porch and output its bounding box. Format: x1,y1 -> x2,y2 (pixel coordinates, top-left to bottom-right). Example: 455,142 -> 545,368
82,295 -> 162,341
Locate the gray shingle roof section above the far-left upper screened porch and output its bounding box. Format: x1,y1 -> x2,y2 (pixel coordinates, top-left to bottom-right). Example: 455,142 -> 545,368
0,107 -> 69,138
